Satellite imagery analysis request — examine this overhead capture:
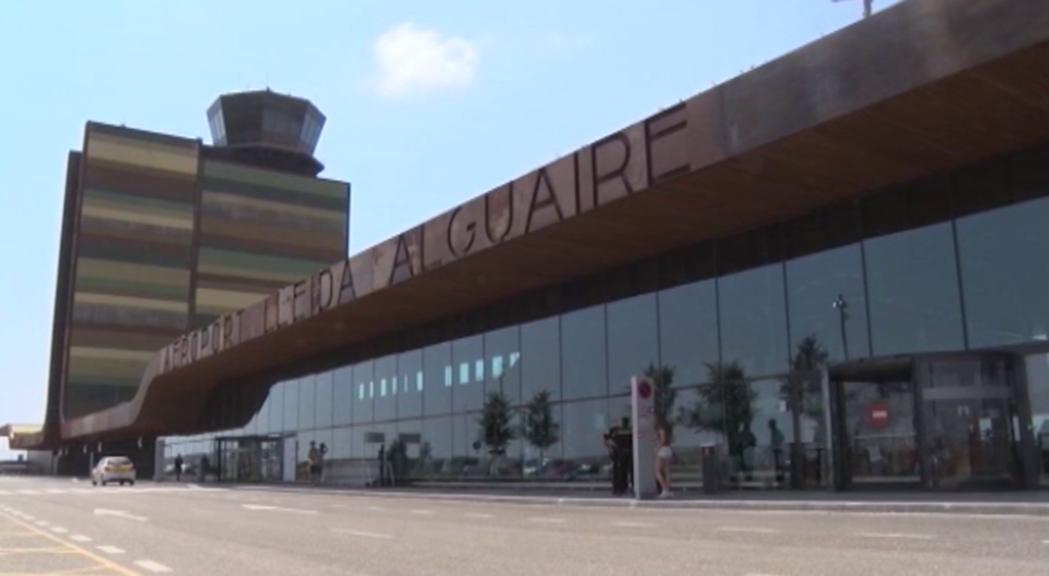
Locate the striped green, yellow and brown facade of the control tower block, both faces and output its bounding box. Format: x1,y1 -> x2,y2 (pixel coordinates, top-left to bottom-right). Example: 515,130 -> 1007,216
60,123 -> 348,418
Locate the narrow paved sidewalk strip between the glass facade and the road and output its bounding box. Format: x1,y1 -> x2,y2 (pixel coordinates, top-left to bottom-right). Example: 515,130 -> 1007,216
222,485 -> 1049,517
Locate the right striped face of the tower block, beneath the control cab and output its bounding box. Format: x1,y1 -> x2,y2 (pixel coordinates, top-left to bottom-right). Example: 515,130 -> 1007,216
193,161 -> 348,325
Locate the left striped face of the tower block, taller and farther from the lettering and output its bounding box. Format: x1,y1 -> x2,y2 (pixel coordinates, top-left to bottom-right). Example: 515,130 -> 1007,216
64,124 -> 199,418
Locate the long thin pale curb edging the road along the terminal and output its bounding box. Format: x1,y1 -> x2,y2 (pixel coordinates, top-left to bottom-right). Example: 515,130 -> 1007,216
228,485 -> 1049,517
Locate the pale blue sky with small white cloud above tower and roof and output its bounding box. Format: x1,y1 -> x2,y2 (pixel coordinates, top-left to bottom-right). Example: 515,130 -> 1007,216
0,0 -> 891,458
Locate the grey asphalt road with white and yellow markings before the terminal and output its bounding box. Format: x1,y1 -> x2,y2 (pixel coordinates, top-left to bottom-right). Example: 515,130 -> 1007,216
0,476 -> 1049,576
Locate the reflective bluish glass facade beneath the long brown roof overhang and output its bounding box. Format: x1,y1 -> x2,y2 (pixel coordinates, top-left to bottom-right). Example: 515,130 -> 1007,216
167,147 -> 1049,488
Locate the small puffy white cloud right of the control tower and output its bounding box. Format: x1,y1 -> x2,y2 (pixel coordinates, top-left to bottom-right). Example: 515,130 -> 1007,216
373,22 -> 477,98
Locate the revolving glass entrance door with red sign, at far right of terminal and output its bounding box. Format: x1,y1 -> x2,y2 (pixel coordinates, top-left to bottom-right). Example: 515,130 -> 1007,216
831,354 -> 1021,490
